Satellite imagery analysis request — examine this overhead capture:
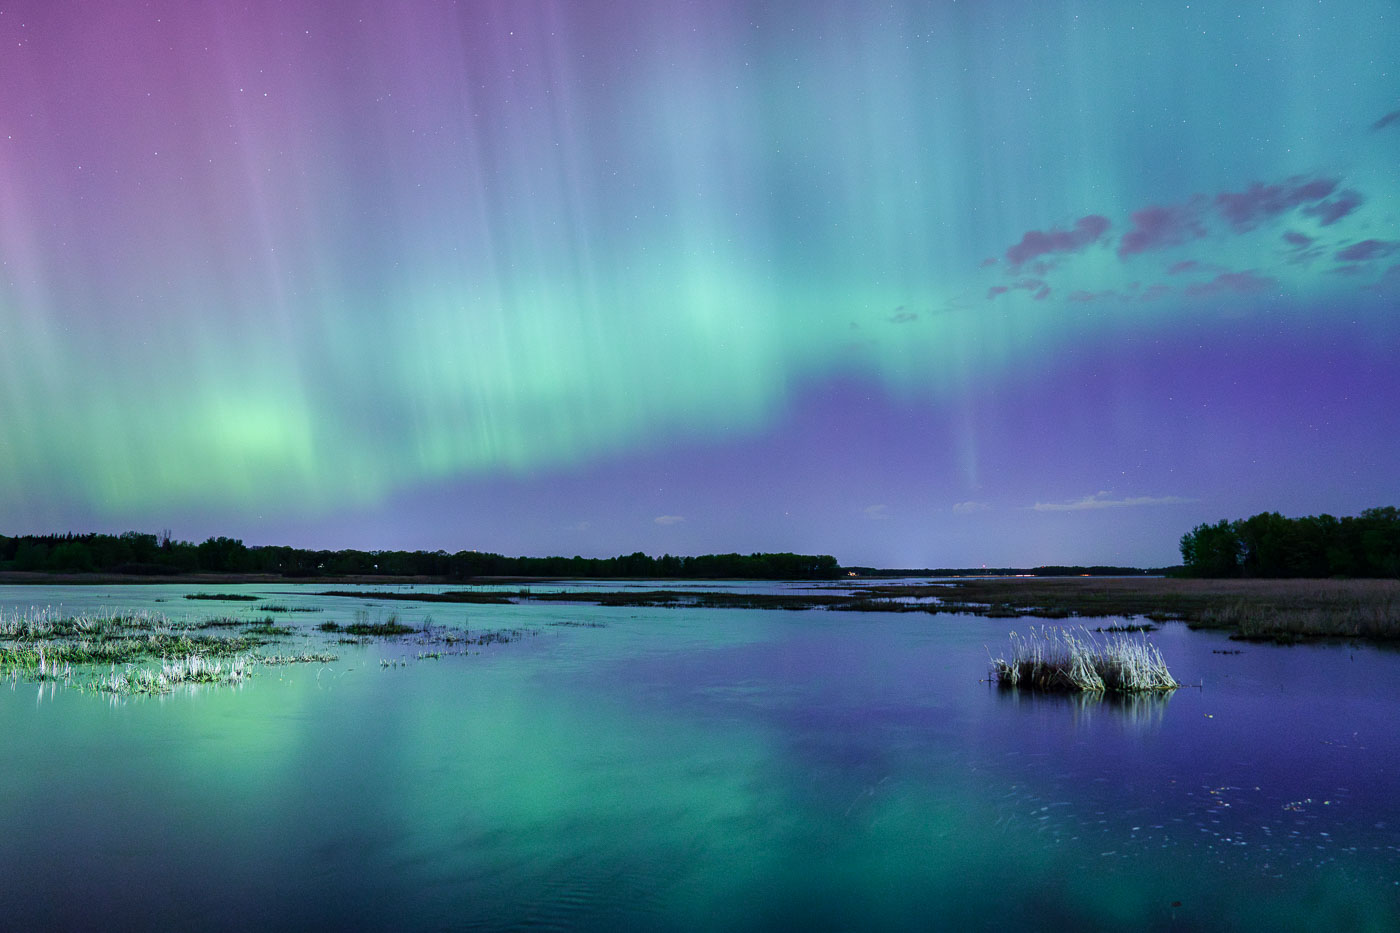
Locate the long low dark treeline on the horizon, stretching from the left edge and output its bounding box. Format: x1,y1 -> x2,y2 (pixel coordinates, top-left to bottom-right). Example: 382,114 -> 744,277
0,531 -> 841,580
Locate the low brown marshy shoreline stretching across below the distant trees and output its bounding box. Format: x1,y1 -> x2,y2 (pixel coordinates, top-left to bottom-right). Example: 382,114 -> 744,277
0,572 -> 1400,643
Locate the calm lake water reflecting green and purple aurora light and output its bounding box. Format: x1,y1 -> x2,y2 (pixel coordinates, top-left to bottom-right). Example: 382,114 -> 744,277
0,586 -> 1400,930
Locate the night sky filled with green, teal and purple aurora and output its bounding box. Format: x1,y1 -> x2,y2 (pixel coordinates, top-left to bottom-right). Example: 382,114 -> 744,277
0,0 -> 1400,566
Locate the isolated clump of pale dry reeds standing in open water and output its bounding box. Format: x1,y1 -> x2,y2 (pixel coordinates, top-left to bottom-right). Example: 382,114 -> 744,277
991,628 -> 1180,693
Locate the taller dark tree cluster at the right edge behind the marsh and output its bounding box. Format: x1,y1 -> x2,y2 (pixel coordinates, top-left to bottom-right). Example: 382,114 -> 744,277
1182,507 -> 1400,577
